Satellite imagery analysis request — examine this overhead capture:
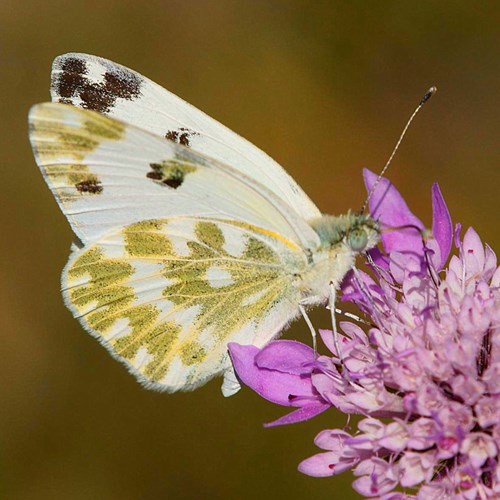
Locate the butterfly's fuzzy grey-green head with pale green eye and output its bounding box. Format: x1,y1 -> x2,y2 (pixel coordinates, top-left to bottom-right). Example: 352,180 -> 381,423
311,212 -> 380,255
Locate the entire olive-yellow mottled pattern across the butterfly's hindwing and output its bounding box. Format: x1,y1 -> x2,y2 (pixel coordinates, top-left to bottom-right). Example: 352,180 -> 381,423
68,218 -> 302,382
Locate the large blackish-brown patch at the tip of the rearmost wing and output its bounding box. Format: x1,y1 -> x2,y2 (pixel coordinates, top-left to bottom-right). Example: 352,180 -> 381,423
53,57 -> 141,113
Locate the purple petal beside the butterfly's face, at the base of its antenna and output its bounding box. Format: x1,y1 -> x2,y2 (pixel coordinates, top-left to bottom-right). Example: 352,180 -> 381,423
363,168 -> 424,255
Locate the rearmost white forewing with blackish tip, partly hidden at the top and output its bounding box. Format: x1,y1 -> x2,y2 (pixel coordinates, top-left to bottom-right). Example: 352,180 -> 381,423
51,53 -> 321,220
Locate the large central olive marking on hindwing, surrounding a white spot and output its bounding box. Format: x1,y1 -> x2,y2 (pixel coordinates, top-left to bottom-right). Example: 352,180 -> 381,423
158,222 -> 289,348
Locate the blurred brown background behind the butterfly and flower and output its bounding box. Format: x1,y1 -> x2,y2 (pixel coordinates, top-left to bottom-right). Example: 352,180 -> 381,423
0,0 -> 500,500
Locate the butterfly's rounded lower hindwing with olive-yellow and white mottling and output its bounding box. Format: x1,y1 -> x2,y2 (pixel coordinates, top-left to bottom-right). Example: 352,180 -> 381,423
63,217 -> 307,392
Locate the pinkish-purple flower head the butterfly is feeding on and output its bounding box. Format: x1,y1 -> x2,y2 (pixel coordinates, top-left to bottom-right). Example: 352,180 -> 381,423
231,171 -> 500,499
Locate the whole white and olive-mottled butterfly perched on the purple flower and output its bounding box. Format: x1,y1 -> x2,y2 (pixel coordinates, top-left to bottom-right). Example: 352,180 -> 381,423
29,53 -> 380,395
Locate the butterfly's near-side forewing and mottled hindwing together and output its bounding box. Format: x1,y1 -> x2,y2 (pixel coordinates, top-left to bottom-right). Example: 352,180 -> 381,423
30,103 -> 319,391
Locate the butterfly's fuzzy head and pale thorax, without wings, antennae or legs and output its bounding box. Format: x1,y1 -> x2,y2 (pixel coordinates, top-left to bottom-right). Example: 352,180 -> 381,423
301,212 -> 380,302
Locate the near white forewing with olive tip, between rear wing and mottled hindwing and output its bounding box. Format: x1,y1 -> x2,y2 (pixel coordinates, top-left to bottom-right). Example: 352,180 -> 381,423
30,103 -> 317,247
